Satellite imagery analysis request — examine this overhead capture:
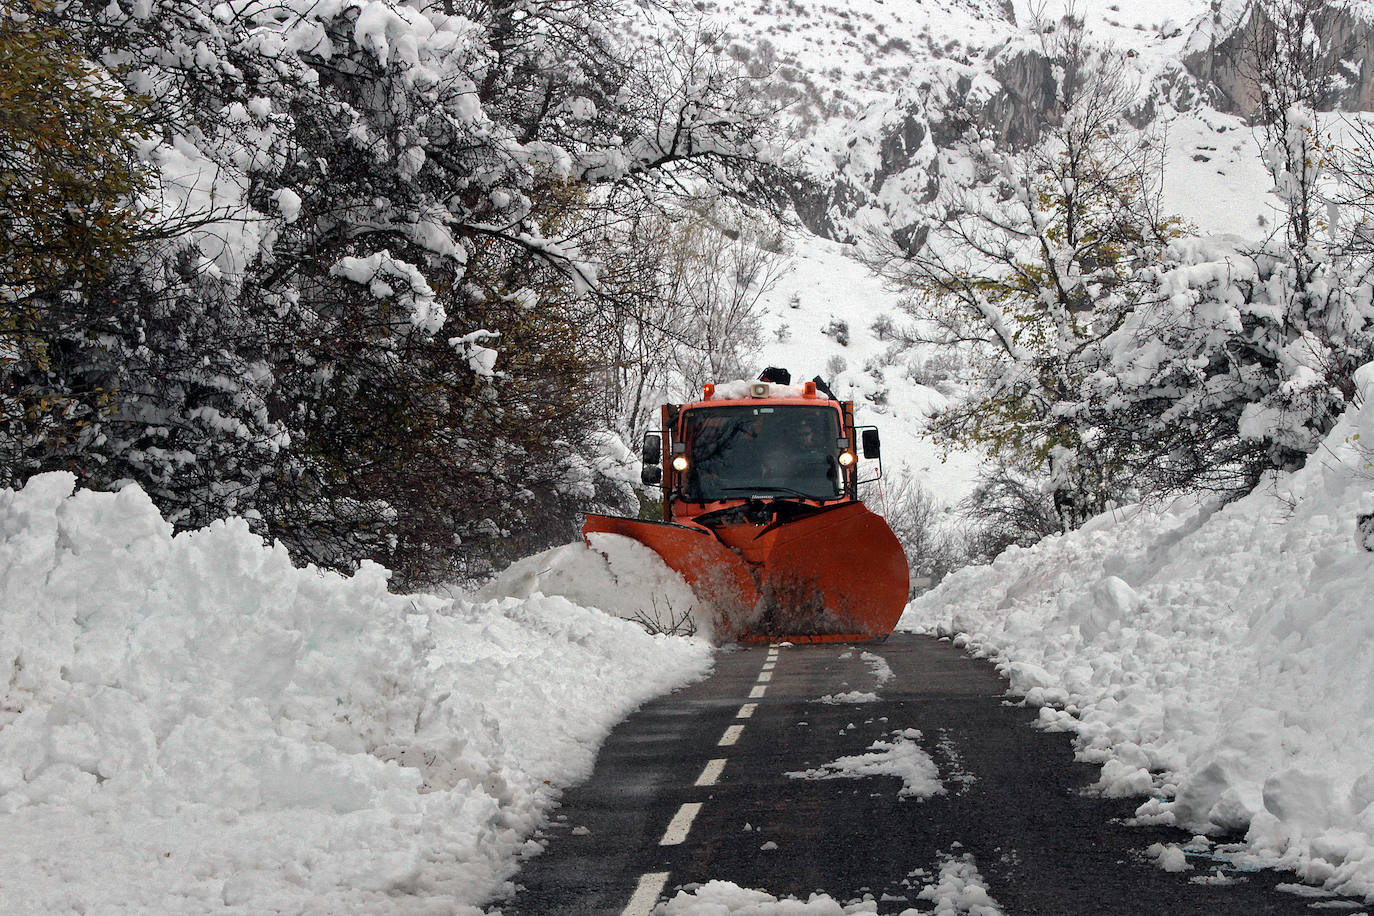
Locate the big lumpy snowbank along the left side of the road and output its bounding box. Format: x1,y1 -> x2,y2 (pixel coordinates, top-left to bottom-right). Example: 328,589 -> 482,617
0,474 -> 710,913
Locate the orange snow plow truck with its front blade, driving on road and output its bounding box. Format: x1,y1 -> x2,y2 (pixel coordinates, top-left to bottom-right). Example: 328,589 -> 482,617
583,369 -> 910,643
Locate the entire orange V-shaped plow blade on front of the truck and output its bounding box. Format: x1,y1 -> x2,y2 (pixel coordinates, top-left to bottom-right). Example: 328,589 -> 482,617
583,503 -> 908,643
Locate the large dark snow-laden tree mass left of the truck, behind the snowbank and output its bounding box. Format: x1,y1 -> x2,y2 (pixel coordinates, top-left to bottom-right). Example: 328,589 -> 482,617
4,0 -> 791,581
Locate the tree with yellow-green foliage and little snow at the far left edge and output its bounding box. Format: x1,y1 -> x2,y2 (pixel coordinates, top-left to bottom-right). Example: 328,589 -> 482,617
0,3 -> 156,480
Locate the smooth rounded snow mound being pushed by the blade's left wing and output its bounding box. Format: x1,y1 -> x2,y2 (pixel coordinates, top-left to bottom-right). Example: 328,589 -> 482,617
477,534 -> 714,639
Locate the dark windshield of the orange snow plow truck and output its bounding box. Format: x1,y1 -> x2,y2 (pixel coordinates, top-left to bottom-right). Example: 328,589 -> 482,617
686,407 -> 844,501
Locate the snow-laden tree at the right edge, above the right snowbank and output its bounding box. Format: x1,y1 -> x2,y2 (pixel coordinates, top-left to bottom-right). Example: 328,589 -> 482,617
1065,0 -> 1374,496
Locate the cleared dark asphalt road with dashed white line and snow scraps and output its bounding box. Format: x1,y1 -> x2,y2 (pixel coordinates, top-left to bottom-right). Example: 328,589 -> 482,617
491,633 -> 1352,916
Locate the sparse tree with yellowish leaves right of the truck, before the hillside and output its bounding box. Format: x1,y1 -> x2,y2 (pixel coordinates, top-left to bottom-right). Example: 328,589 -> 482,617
872,19 -> 1179,525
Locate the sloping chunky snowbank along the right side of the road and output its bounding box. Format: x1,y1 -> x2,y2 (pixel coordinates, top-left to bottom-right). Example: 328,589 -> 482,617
899,367 -> 1374,900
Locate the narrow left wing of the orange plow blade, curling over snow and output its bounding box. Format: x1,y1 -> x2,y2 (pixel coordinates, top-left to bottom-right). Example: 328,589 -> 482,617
583,515 -> 758,626
